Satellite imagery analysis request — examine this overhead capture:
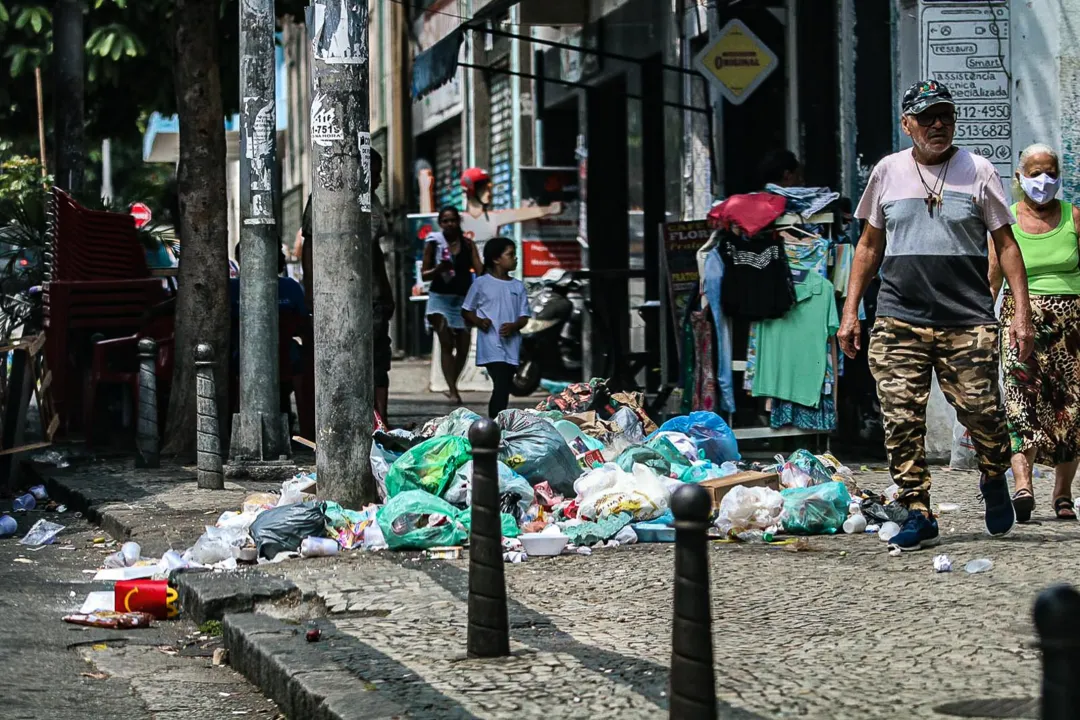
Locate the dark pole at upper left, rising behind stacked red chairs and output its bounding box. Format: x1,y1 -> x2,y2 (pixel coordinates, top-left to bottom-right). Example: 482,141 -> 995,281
53,0 -> 86,193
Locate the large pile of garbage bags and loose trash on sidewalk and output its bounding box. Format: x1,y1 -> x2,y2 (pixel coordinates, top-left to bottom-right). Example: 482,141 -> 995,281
185,380 -> 887,567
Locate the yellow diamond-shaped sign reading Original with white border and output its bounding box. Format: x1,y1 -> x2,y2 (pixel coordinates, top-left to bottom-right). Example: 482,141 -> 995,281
696,21 -> 780,105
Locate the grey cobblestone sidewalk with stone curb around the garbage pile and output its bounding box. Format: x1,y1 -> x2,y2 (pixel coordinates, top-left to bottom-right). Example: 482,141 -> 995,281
23,446 -> 1062,720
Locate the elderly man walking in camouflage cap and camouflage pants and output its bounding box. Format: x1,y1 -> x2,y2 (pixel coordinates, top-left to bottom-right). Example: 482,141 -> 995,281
838,80 -> 1034,551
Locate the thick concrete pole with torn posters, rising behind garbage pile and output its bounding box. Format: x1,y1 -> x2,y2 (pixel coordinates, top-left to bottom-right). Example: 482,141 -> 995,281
307,0 -> 378,507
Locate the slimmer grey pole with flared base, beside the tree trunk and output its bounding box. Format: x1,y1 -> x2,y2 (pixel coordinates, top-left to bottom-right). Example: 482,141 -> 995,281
230,0 -> 291,463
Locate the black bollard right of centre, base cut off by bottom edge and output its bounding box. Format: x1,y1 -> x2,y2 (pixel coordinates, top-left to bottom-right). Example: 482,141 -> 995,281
665,485 -> 716,720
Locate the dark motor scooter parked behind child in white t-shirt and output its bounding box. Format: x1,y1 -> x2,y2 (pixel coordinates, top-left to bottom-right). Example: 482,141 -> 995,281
511,269 -> 585,397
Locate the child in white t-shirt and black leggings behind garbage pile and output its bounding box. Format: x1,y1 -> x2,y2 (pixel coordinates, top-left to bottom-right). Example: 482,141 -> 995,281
461,237 -> 529,418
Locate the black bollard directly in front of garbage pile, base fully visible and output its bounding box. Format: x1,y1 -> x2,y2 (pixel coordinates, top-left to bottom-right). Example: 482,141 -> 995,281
468,419 -> 510,657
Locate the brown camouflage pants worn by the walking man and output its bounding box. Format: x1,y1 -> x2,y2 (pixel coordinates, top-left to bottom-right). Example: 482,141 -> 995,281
869,317 -> 1009,510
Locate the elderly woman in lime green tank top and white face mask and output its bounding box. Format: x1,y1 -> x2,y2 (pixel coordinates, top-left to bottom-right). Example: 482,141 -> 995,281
991,145 -> 1080,522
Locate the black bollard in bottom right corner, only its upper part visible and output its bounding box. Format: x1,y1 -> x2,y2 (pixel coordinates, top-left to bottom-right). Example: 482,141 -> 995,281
1032,585 -> 1080,720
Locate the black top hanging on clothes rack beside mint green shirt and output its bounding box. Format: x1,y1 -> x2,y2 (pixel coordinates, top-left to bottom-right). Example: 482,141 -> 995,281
720,231 -> 795,321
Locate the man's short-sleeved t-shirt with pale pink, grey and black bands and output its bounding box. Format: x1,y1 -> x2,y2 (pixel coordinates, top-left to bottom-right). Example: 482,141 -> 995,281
855,149 -> 1015,327
